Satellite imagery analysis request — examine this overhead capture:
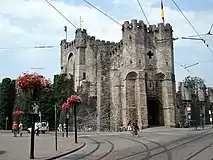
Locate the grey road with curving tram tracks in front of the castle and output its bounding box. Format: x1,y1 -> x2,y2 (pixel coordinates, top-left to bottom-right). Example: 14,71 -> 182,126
61,129 -> 213,160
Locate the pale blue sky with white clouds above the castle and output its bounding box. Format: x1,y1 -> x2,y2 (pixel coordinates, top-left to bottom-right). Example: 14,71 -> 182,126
0,0 -> 213,86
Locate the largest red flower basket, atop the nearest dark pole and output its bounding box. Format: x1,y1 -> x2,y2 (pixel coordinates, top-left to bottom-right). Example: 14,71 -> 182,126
16,73 -> 49,89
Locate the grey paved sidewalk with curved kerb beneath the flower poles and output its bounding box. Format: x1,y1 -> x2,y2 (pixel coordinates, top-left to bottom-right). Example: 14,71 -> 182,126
0,133 -> 85,160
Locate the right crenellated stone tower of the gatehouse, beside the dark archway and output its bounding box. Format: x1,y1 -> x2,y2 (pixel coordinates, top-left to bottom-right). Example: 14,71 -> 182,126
154,23 -> 176,126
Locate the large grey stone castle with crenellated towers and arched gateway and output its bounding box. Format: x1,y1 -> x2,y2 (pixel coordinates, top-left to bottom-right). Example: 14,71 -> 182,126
61,20 -> 176,130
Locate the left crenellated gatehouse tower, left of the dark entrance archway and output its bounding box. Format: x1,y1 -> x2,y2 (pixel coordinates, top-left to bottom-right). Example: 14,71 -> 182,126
120,20 -> 147,129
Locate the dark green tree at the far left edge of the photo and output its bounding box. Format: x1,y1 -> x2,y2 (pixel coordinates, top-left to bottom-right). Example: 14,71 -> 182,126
0,78 -> 16,128
